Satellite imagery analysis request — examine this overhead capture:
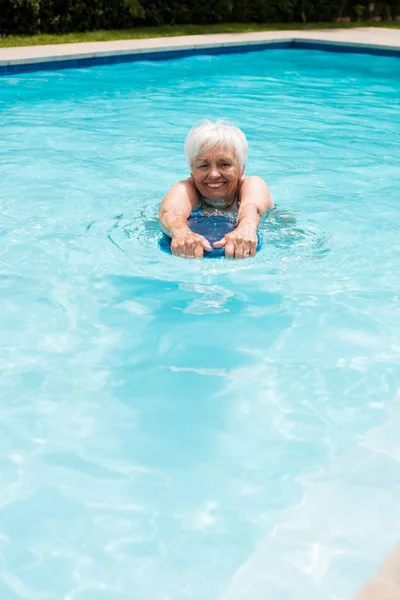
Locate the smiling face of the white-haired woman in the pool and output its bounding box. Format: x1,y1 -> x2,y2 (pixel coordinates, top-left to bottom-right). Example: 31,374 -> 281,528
192,146 -> 243,206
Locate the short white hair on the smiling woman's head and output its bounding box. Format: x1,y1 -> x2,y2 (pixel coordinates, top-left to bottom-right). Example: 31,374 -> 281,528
185,120 -> 248,169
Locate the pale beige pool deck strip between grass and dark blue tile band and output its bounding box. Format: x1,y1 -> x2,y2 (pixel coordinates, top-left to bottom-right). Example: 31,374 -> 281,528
0,27 -> 400,67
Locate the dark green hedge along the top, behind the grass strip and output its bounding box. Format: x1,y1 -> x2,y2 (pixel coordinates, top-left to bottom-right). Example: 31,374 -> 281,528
0,0 -> 400,35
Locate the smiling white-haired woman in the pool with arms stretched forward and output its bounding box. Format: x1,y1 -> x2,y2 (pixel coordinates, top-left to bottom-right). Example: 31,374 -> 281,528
160,121 -> 274,258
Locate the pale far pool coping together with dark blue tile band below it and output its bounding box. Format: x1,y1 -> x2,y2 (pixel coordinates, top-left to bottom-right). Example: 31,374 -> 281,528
0,27 -> 400,75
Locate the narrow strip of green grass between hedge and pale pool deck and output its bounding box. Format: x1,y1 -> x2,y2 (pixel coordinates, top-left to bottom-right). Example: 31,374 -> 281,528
0,21 -> 400,48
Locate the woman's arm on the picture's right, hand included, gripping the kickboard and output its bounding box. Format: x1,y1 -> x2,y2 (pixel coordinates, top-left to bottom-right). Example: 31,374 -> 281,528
214,177 -> 274,258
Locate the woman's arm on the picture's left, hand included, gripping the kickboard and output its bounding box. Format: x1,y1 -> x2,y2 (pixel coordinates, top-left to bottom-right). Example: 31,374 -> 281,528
160,179 -> 212,258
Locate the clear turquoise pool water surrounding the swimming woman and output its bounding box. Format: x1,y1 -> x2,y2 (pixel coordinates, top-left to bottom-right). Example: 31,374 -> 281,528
0,50 -> 400,600
